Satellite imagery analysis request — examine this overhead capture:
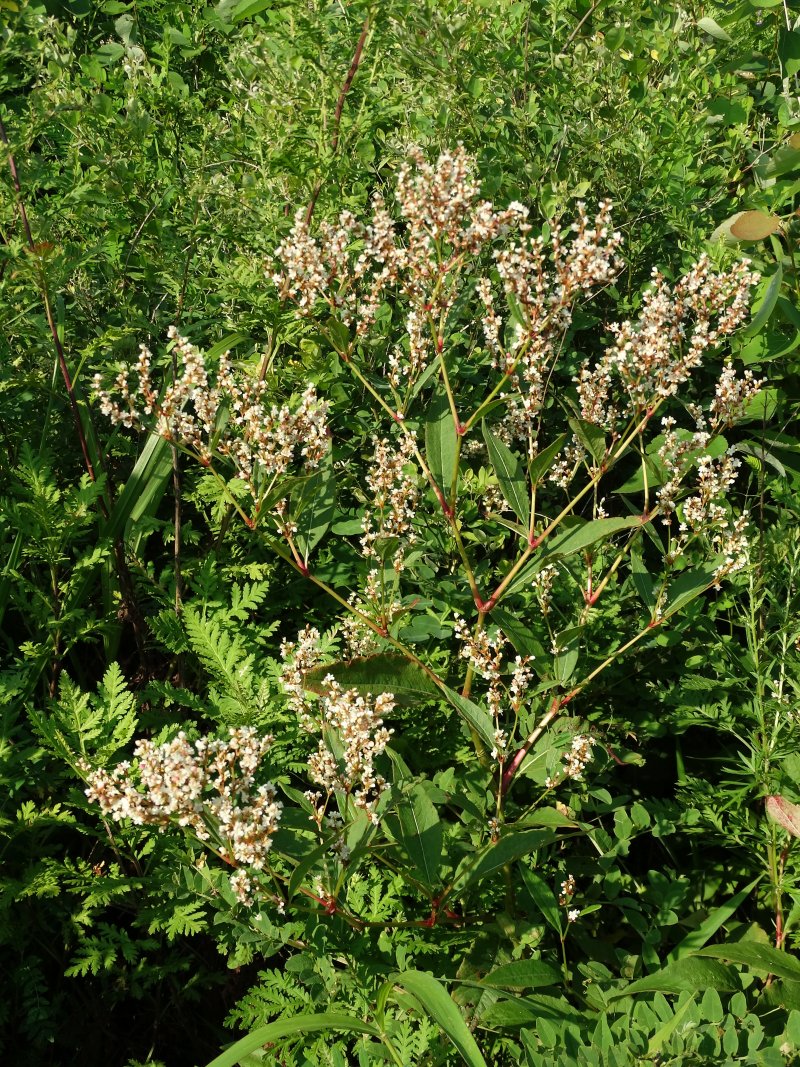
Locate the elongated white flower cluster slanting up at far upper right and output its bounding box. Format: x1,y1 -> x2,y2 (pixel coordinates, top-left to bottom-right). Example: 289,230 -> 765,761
576,256 -> 758,430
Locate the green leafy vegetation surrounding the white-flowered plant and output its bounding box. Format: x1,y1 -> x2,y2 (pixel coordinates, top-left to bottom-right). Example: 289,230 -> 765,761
0,0 -> 800,1067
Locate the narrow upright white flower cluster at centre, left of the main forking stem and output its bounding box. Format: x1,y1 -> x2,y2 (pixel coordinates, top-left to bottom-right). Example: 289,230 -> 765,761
362,433 -> 418,573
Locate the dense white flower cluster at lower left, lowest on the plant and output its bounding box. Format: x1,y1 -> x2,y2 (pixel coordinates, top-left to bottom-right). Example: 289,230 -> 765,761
85,727 -> 283,903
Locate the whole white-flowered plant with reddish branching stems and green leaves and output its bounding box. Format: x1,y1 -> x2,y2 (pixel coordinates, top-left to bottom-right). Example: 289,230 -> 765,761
87,147 -> 761,1062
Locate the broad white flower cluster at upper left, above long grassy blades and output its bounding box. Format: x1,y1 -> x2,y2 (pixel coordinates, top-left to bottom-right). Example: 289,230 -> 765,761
94,327 -> 330,497
